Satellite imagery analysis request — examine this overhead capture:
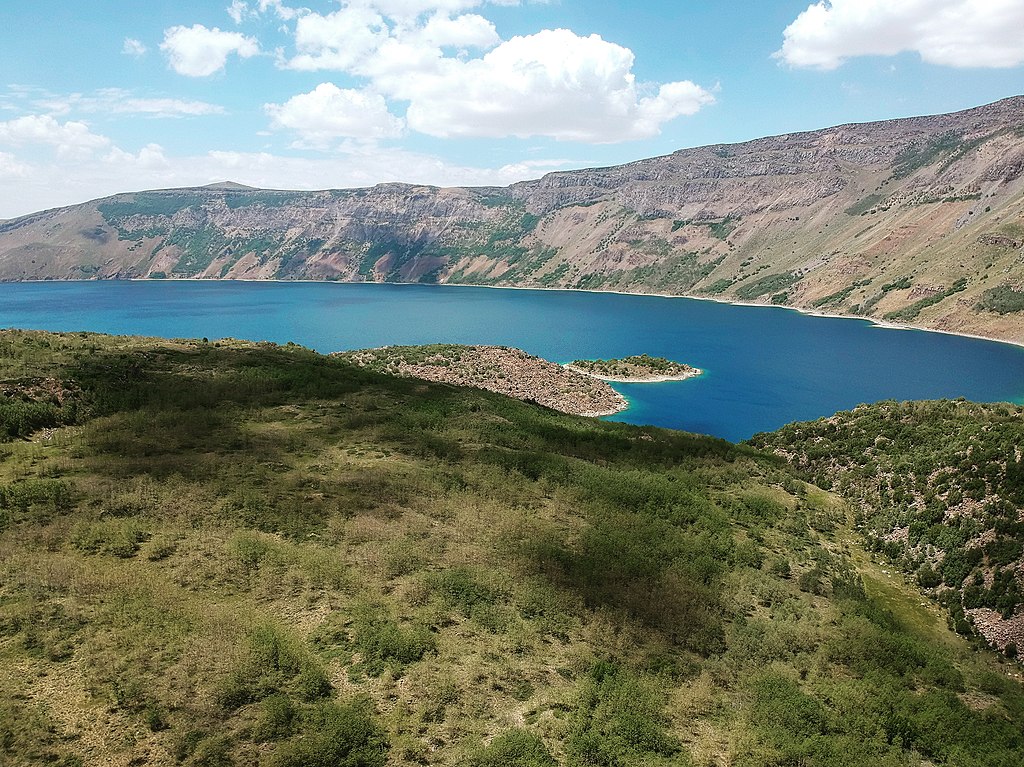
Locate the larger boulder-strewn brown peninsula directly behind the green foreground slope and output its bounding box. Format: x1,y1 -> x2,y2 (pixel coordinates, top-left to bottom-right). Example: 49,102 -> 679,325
334,344 -> 629,417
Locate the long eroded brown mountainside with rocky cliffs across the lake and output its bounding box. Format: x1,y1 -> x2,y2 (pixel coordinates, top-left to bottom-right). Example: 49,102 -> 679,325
0,97 -> 1024,341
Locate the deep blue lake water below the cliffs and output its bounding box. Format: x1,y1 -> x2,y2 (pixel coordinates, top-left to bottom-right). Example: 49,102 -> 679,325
0,281 -> 1024,440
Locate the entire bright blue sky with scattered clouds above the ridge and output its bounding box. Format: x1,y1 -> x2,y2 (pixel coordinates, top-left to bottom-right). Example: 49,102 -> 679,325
0,0 -> 1024,219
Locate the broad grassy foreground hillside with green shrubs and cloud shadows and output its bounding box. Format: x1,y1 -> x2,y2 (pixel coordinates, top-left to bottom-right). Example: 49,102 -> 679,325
0,331 -> 1024,767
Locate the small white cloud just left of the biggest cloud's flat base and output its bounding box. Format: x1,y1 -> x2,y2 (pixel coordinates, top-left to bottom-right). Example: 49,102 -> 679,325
263,83 -> 402,147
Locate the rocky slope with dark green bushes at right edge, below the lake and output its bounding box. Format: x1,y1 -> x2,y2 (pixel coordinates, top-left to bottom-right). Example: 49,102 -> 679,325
752,400 -> 1024,655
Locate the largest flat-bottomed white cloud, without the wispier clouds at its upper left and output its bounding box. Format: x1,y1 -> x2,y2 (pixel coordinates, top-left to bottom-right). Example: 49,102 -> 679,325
399,30 -> 715,143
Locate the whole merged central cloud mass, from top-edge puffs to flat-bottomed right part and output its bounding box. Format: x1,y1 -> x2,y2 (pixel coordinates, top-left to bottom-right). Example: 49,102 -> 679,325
280,5 -> 715,142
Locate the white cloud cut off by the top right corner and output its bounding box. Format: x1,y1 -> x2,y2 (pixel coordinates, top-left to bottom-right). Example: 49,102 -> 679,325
775,0 -> 1024,70
